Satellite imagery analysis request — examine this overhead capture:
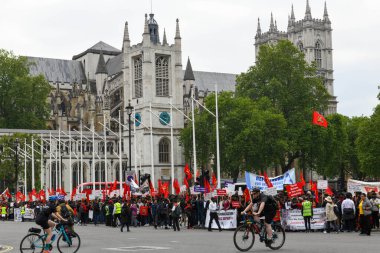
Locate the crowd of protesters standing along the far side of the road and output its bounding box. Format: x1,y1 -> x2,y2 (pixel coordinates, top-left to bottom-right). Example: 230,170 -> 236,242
0,188 -> 380,235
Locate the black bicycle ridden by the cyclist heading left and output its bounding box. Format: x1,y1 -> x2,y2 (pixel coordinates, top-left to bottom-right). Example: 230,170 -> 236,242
234,215 -> 285,251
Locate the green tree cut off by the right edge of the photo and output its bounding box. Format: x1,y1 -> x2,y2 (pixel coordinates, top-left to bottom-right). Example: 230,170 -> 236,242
357,105 -> 380,177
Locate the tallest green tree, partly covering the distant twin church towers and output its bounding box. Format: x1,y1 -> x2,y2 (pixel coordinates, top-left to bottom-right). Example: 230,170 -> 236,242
237,40 -> 330,171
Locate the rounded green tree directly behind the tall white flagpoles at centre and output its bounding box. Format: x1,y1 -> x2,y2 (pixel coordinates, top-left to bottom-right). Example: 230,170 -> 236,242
181,92 -> 286,179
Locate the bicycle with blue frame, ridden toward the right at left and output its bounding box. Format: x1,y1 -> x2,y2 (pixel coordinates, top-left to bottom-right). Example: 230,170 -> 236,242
20,223 -> 81,253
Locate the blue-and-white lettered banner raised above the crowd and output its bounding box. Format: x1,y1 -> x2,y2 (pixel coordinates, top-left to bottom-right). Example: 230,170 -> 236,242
245,168 -> 296,191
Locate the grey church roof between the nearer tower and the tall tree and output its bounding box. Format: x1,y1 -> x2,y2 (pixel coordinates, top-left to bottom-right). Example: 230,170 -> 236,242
194,71 -> 237,92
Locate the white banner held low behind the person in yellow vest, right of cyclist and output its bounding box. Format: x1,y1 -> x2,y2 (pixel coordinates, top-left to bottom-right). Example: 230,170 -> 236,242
281,208 -> 326,231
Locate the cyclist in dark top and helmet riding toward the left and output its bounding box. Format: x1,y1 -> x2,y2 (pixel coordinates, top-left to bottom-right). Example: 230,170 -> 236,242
241,187 -> 277,246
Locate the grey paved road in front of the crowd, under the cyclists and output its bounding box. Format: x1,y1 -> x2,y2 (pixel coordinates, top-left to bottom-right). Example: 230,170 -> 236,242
0,222 -> 380,253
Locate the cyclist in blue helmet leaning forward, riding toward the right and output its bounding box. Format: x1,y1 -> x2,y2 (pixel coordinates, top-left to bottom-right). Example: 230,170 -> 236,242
36,196 -> 67,253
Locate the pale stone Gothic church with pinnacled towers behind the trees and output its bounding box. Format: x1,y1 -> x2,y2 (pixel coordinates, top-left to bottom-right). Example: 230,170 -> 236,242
19,1 -> 337,191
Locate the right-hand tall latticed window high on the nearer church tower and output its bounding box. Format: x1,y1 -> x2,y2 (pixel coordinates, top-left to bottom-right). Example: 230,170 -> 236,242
156,56 -> 169,97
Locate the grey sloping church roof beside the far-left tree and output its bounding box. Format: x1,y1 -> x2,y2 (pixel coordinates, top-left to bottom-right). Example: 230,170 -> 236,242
27,56 -> 86,83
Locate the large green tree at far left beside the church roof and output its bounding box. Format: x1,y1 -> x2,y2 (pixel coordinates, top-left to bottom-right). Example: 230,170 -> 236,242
0,50 -> 50,129
